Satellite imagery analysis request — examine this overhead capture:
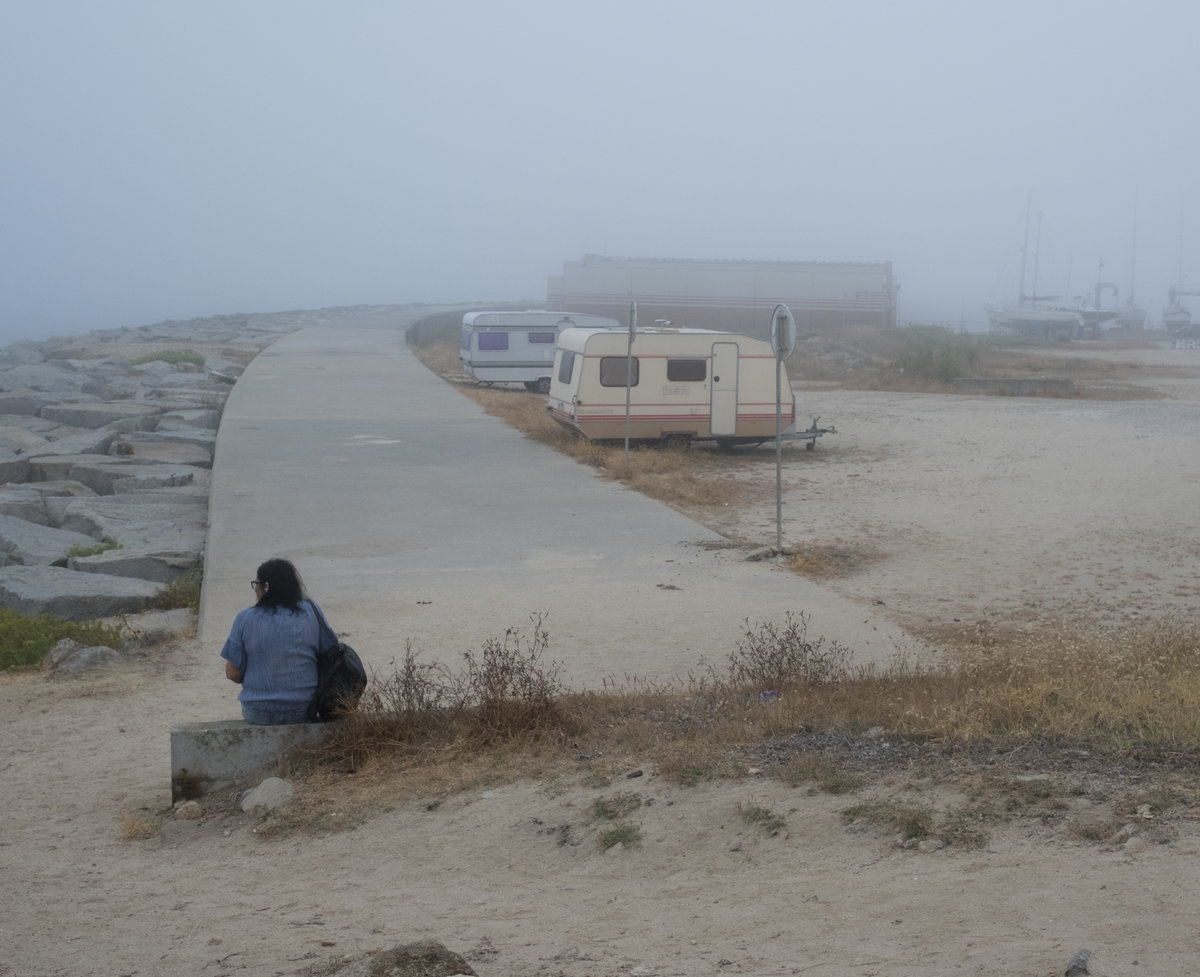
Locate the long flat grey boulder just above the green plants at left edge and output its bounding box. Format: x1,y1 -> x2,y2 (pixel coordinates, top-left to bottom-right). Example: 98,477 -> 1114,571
0,567 -> 162,621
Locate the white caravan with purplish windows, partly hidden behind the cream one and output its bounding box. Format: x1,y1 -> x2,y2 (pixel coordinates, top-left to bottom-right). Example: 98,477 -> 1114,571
458,310 -> 623,394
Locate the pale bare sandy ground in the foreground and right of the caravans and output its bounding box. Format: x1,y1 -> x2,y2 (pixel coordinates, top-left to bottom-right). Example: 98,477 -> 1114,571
0,340 -> 1200,977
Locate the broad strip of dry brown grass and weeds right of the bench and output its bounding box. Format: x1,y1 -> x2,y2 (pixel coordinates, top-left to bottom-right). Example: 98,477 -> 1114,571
248,619 -> 1200,847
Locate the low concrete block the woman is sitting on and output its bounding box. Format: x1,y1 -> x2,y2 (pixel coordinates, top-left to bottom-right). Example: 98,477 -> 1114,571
170,719 -> 328,804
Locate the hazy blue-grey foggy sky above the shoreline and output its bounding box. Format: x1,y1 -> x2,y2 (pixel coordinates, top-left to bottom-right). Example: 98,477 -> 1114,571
0,0 -> 1200,342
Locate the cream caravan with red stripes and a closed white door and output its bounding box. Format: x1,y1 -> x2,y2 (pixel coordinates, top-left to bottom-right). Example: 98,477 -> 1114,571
547,328 -> 796,445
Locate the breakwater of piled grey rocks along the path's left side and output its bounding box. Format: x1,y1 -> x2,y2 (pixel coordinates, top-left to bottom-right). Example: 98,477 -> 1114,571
0,312 -> 320,621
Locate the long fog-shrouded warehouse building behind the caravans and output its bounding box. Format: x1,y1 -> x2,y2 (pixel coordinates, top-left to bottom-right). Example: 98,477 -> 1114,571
546,254 -> 899,336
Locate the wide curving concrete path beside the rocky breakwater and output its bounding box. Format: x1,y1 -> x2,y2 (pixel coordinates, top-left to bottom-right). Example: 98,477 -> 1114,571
200,316 -> 902,691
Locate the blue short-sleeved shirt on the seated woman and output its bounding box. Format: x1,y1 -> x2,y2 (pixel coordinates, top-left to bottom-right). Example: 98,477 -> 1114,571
221,601 -> 320,711
